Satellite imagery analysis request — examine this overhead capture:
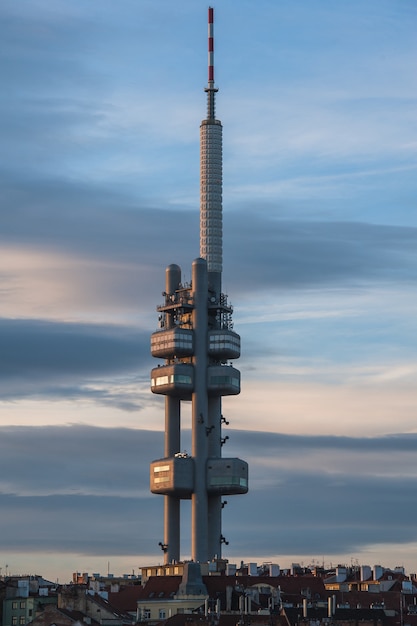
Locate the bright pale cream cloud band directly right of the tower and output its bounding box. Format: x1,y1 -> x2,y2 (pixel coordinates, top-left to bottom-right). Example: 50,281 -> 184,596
223,378 -> 417,436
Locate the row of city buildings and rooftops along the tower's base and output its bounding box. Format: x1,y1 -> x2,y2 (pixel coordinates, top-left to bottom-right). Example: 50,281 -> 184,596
0,561 -> 417,626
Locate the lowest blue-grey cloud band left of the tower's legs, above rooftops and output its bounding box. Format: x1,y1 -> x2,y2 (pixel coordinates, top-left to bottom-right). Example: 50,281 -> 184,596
0,495 -> 158,556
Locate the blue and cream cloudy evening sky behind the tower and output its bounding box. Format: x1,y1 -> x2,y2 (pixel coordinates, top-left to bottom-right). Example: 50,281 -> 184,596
0,0 -> 417,582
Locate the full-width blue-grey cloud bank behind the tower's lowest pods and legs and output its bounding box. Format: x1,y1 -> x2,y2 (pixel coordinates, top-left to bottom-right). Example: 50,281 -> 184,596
0,425 -> 417,557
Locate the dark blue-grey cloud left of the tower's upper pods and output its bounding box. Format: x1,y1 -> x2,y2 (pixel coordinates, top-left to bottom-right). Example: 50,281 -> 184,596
0,319 -> 151,410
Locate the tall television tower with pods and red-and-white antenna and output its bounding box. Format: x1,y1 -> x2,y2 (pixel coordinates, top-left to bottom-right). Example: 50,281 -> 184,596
150,8 -> 248,564
